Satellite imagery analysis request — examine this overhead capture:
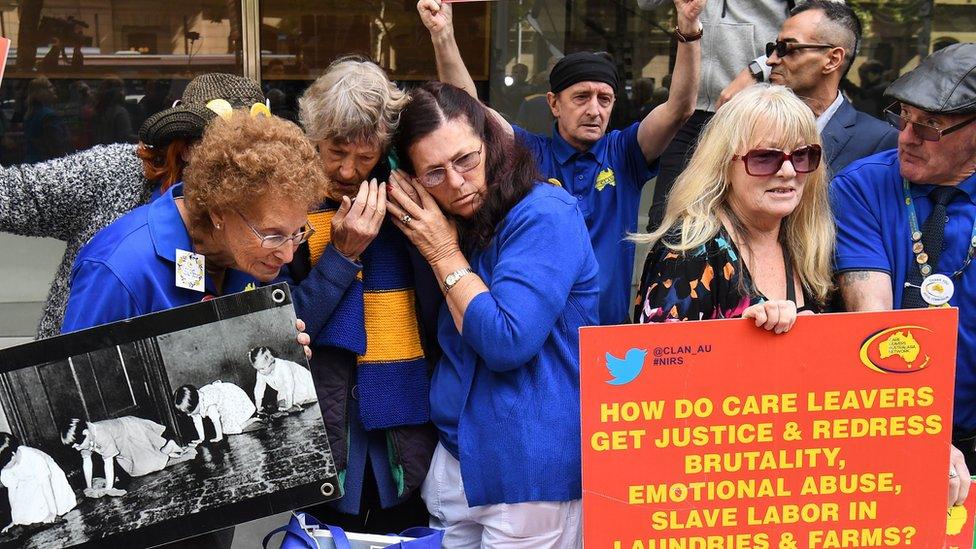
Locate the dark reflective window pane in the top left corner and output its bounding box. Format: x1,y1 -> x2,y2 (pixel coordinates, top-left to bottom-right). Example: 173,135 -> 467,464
0,0 -> 243,165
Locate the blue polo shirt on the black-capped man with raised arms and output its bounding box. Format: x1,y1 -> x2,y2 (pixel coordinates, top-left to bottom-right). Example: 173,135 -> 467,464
513,122 -> 658,325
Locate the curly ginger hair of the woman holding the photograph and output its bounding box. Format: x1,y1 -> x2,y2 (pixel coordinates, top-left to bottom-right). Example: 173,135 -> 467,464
183,111 -> 328,228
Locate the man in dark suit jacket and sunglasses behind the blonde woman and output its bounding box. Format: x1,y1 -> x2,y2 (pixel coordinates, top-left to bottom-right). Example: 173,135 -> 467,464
719,0 -> 898,174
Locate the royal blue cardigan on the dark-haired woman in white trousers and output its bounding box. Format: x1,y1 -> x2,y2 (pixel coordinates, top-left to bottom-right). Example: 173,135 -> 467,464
430,183 -> 599,506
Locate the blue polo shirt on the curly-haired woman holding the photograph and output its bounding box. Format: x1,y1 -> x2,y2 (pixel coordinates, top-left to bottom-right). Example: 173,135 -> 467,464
61,184 -> 256,333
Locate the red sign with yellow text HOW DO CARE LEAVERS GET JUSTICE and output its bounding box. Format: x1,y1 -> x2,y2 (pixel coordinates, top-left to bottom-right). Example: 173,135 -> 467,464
580,309 -> 958,549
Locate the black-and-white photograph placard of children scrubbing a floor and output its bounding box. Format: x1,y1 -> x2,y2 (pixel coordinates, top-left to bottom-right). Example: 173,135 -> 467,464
0,285 -> 339,547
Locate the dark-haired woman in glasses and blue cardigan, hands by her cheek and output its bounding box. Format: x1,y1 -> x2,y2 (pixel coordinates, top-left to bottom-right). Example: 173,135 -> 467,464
388,79 -> 599,548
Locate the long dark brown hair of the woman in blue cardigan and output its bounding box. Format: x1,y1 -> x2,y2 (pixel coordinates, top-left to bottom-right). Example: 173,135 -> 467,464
394,82 -> 539,251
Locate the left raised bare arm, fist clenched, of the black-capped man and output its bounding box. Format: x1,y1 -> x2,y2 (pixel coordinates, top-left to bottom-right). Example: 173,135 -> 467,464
417,0 -> 515,135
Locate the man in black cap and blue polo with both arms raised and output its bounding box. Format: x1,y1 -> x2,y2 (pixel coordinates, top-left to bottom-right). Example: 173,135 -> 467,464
417,0 -> 705,324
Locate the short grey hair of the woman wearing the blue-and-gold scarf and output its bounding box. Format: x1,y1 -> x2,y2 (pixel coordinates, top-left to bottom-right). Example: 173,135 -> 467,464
298,56 -> 409,149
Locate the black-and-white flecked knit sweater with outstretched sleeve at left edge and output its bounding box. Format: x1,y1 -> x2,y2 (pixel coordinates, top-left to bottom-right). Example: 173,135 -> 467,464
0,144 -> 152,337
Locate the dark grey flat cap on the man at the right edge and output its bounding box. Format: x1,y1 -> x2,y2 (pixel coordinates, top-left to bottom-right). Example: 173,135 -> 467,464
885,42 -> 976,114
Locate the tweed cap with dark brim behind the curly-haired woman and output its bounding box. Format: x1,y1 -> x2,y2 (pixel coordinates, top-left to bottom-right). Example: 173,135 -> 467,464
139,72 -> 266,147
